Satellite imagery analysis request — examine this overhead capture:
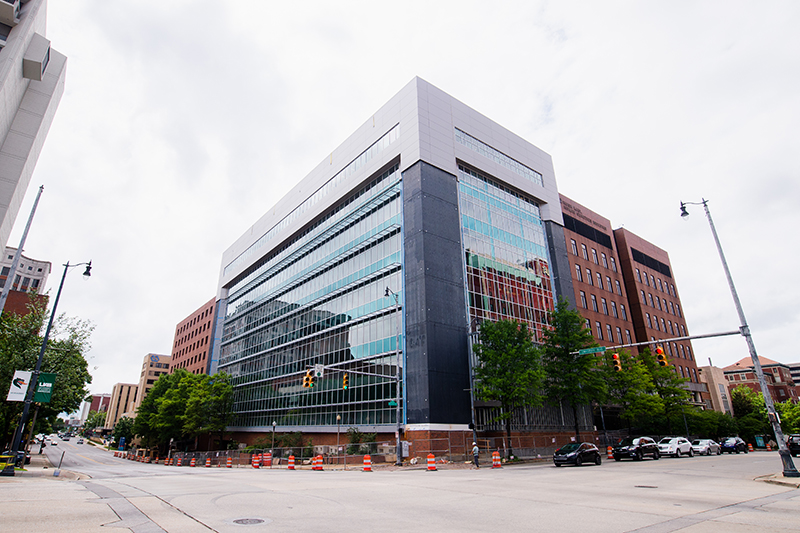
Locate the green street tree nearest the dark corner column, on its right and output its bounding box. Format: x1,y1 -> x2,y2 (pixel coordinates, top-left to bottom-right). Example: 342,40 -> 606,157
473,320 -> 543,457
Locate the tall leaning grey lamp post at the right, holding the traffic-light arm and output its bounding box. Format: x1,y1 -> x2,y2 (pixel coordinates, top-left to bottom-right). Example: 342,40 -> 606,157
681,198 -> 800,477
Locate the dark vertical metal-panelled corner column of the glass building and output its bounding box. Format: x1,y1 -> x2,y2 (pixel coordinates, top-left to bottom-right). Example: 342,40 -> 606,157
403,161 -> 470,424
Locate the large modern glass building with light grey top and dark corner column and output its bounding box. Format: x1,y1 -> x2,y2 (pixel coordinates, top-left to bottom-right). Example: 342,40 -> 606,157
211,78 -> 576,435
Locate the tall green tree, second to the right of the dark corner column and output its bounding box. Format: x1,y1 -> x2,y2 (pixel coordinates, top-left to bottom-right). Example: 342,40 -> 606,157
542,298 -> 605,441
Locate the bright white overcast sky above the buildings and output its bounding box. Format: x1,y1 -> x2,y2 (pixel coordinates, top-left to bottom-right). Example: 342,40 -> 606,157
8,0 -> 800,393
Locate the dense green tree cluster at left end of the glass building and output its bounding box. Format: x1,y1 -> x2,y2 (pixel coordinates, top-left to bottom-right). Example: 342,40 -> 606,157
134,368 -> 233,449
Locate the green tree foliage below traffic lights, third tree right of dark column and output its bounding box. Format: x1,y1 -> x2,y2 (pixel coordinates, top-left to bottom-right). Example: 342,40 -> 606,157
600,350 -> 664,428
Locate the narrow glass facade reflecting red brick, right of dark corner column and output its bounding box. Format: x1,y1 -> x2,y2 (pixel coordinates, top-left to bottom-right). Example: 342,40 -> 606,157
458,166 -> 553,338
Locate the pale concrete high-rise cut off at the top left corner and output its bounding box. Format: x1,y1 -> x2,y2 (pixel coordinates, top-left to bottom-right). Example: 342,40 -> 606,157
0,0 -> 67,247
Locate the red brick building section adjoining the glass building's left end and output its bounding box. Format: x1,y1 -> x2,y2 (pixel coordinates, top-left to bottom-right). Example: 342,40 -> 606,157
170,298 -> 216,374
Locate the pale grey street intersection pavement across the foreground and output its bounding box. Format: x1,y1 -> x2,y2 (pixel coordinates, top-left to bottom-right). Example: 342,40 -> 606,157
0,442 -> 800,532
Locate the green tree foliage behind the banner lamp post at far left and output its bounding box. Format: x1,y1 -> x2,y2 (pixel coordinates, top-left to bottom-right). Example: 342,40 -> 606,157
0,296 -> 94,446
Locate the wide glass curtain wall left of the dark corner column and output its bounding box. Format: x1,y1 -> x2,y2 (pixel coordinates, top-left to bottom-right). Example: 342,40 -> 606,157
219,166 -> 403,428
